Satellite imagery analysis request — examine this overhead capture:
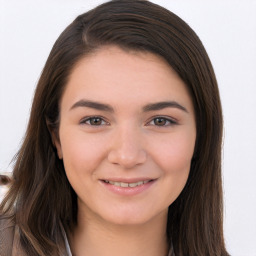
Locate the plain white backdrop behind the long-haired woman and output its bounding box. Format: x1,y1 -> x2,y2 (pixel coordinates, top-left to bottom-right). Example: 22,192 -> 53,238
0,0 -> 256,256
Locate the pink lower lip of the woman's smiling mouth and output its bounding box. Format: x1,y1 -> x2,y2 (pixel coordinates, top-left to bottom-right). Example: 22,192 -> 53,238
100,180 -> 156,196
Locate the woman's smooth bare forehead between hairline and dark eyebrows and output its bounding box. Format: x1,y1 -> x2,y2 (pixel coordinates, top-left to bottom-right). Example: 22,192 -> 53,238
61,46 -> 191,113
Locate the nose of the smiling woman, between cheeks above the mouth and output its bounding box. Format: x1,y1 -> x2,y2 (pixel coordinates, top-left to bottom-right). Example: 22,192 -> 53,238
108,127 -> 147,169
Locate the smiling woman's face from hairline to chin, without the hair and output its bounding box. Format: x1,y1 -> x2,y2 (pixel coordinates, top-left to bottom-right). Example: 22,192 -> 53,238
55,46 -> 196,224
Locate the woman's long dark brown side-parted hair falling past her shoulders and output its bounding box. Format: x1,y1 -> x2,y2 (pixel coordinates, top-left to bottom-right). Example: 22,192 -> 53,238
0,0 -> 228,256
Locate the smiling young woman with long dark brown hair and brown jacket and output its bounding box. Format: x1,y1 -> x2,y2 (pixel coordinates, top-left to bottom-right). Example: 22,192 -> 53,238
0,0 -> 228,256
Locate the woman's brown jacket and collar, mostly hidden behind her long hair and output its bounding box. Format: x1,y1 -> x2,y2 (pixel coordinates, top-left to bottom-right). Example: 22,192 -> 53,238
0,219 -> 174,256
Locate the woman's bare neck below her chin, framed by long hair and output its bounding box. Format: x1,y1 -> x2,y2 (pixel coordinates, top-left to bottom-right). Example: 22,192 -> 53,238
70,207 -> 168,256
